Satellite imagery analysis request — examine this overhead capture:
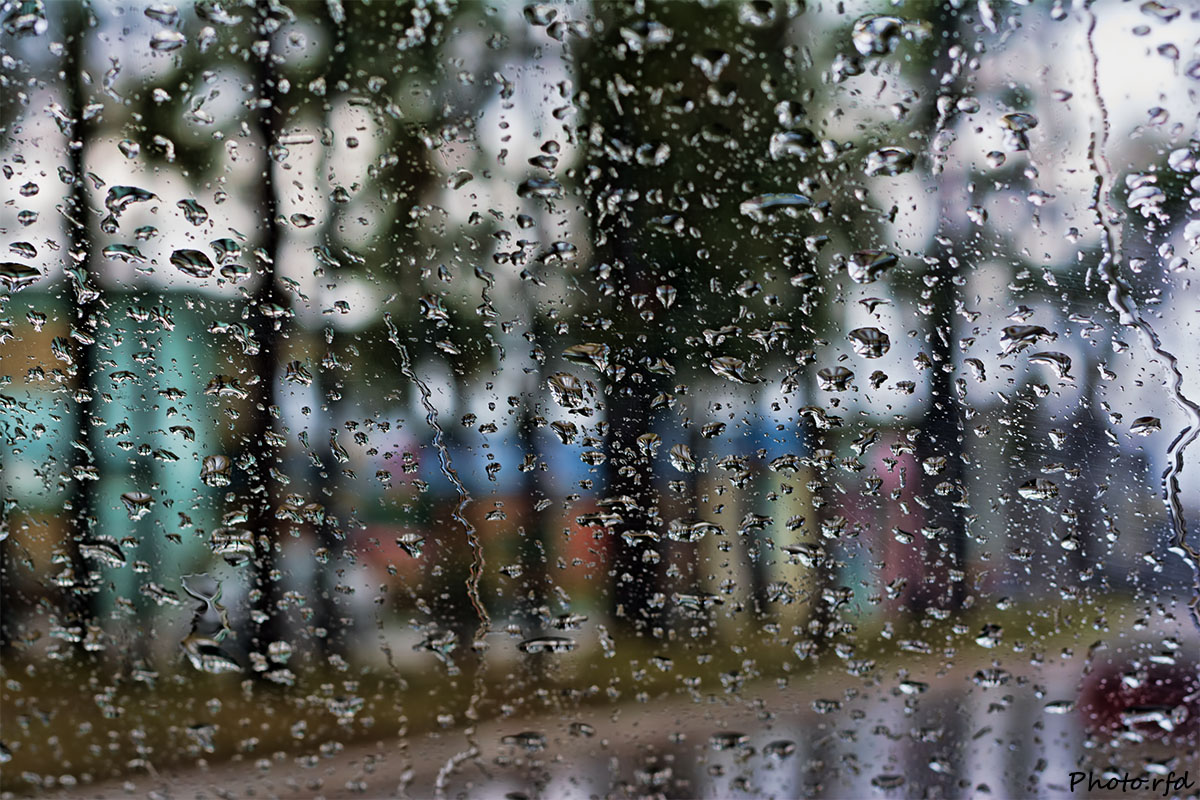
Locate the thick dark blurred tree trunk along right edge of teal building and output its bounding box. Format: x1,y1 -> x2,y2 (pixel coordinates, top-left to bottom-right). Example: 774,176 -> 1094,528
246,4 -> 288,669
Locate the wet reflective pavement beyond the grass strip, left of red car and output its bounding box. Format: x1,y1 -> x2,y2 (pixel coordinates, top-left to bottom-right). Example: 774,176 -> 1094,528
32,654 -> 1156,800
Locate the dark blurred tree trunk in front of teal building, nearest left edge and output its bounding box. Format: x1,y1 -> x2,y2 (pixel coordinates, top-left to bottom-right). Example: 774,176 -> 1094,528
62,4 -> 103,657
